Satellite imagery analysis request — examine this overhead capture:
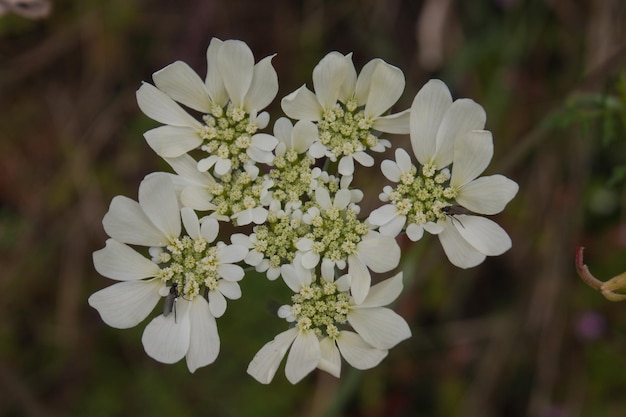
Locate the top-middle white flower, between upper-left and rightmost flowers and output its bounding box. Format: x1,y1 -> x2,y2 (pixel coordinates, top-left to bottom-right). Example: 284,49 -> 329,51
281,52 -> 409,175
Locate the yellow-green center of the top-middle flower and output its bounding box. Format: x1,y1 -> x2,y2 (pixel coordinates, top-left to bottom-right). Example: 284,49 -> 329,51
318,99 -> 378,158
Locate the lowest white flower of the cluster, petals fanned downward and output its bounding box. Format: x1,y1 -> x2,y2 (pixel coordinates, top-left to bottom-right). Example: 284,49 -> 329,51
248,265 -> 411,384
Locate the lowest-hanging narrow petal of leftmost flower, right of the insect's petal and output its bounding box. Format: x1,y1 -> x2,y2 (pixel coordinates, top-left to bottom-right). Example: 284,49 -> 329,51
187,297 -> 220,373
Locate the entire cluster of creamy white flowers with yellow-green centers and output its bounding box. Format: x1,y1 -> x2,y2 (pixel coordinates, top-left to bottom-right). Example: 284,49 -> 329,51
89,39 -> 517,383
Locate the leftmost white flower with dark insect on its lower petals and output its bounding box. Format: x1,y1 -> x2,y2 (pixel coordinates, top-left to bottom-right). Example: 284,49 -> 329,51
89,174 -> 248,372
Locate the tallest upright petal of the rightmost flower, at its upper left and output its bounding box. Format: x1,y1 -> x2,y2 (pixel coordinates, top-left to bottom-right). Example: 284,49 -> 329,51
411,80 -> 452,164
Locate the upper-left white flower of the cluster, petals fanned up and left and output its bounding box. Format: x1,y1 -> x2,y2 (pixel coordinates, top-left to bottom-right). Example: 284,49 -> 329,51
137,38 -> 278,176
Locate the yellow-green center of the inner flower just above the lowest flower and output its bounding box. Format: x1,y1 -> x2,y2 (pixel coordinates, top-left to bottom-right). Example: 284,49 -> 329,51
306,201 -> 369,262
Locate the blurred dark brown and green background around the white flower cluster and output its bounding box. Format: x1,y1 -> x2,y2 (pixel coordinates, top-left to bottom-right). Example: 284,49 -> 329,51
0,0 -> 626,417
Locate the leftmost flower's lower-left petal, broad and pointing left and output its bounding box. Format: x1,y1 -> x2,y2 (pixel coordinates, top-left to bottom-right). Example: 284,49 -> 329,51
88,280 -> 162,329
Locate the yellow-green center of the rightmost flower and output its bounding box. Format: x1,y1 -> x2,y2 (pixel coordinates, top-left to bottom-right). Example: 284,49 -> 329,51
389,164 -> 457,225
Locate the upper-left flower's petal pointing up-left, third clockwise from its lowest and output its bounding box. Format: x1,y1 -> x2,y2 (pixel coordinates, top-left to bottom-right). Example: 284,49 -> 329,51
152,61 -> 211,113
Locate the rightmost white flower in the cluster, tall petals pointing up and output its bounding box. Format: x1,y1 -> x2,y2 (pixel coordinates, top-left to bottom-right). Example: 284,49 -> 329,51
368,80 -> 518,268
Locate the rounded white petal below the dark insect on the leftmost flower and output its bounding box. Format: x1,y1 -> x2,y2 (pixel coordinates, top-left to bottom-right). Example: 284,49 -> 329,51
141,298 -> 191,363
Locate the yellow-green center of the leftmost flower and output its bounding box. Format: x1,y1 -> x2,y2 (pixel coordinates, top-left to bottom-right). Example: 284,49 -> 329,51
155,236 -> 219,300
